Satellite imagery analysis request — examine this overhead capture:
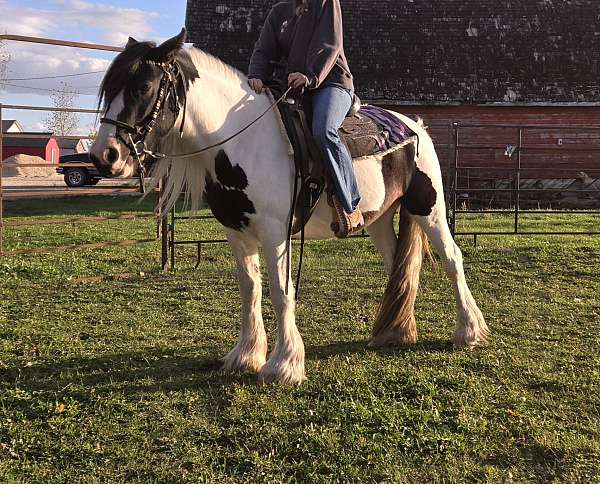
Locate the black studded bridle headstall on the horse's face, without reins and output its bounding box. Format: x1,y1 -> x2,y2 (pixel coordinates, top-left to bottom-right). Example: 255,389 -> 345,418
100,60 -> 187,193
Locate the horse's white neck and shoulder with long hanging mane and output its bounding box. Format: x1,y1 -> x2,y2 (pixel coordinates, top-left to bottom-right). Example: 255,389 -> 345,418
154,51 -> 293,214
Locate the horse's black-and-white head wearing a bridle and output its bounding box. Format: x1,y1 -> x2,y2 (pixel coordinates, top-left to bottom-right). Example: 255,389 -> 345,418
90,29 -> 186,177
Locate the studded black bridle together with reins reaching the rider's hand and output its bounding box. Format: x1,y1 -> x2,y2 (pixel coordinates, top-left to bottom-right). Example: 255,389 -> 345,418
100,55 -> 292,193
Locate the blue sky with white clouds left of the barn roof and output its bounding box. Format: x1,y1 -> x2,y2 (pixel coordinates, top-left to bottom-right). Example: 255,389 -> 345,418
0,0 -> 186,134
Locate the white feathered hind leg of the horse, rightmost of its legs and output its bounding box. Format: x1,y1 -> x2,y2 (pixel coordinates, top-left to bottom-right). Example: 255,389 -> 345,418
415,202 -> 489,348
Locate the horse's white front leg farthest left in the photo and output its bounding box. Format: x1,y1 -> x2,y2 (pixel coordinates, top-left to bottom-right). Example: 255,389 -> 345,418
223,230 -> 267,372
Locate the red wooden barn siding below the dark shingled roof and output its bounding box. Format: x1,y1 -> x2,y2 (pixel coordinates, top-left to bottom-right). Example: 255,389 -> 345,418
386,105 -> 600,178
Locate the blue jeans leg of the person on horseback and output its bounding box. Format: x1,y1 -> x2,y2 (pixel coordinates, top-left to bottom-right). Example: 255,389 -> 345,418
312,86 -> 360,213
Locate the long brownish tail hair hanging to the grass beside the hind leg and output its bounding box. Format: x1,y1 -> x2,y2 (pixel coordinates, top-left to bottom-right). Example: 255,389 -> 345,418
369,209 -> 430,347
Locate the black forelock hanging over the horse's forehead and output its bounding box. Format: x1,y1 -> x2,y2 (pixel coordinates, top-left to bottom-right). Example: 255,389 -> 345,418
98,42 -> 156,109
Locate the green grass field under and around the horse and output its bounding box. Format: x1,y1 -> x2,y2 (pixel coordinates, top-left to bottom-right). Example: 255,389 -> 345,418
0,198 -> 600,483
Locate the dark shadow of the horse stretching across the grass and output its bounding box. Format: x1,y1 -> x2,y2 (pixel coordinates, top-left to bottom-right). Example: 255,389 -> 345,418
0,340 -> 452,418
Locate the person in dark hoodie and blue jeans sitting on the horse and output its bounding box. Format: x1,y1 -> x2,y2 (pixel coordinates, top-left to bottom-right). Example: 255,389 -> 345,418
248,0 -> 364,231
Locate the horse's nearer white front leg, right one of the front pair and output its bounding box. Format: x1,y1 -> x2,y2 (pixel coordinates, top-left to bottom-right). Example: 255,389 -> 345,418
260,223 -> 306,384
